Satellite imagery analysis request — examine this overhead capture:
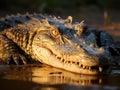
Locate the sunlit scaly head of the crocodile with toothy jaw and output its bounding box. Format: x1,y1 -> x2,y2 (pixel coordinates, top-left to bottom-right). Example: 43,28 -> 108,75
32,20 -> 111,75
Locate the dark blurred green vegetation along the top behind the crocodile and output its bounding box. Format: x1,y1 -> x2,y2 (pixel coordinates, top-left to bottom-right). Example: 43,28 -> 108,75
0,0 -> 120,13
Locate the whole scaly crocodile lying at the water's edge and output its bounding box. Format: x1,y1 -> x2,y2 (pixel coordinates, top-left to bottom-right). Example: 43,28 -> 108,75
0,13 -> 120,75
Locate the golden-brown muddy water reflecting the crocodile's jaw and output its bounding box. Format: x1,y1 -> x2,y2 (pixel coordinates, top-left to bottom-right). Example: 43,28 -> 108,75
0,65 -> 120,90
